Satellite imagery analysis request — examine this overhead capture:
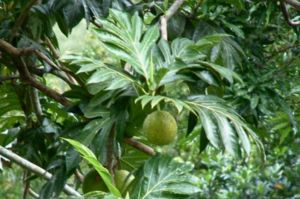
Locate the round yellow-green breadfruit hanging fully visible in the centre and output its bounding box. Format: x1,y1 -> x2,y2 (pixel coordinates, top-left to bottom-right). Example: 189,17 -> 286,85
143,111 -> 177,145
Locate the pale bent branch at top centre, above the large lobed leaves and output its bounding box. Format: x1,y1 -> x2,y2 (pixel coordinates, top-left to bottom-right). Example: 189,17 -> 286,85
160,0 -> 184,40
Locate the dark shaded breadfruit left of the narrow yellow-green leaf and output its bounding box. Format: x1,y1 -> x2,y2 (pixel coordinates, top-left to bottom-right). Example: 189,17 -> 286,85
82,169 -> 108,194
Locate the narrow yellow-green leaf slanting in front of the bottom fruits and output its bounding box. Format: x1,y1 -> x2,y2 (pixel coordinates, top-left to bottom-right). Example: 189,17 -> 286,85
62,138 -> 121,197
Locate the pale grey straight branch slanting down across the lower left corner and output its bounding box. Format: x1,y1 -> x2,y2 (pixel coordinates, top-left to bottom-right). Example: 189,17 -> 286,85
0,146 -> 81,197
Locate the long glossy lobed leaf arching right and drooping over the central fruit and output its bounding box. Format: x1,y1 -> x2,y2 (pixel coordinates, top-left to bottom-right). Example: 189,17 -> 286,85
135,95 -> 264,155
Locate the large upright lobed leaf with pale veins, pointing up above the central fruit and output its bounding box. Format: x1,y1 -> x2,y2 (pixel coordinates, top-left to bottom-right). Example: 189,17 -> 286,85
96,10 -> 159,80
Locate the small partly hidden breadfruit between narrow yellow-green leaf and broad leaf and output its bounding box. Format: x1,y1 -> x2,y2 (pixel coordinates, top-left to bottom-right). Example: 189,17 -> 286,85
114,170 -> 134,194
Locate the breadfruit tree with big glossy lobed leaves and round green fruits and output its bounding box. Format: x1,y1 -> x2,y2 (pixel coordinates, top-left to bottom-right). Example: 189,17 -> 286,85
0,0 -> 299,199
